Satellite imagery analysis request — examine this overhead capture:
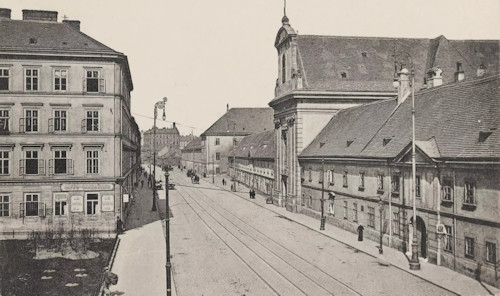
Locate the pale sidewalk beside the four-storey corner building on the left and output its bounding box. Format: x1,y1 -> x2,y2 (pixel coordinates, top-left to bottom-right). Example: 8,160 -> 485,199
111,171 -> 176,295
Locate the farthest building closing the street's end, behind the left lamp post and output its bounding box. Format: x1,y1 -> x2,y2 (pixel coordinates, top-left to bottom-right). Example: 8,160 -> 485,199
142,122 -> 180,163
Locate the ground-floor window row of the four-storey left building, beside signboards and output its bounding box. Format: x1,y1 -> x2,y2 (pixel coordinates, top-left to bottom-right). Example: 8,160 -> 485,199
0,192 -> 105,217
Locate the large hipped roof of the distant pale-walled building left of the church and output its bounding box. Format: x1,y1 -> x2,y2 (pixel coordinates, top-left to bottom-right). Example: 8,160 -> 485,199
202,108 -> 274,136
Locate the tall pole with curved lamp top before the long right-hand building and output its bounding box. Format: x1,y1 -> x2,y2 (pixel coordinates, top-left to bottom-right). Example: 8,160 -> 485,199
392,44 -> 420,270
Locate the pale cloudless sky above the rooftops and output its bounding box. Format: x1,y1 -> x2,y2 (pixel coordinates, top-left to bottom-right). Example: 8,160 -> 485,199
0,0 -> 500,135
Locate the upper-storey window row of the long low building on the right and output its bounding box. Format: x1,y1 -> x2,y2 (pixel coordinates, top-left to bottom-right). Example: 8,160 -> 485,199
309,169 -> 476,205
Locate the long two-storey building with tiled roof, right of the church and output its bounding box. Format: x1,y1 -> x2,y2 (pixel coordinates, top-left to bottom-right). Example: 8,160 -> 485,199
299,71 -> 500,287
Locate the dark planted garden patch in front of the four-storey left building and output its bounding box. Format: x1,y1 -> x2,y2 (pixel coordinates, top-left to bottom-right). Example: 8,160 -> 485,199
0,239 -> 114,296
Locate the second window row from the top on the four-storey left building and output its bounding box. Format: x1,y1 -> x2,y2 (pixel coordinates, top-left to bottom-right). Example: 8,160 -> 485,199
0,108 -> 100,134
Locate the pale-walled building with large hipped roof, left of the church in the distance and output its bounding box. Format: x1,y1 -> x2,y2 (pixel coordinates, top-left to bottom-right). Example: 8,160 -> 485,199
200,108 -> 273,175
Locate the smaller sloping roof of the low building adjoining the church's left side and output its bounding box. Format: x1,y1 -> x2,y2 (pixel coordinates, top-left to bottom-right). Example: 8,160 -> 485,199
228,130 -> 276,159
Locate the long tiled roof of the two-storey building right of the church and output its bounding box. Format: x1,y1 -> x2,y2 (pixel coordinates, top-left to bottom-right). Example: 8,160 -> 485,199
300,75 -> 500,159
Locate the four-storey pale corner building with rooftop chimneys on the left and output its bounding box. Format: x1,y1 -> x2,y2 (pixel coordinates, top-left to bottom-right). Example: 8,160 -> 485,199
0,9 -> 141,233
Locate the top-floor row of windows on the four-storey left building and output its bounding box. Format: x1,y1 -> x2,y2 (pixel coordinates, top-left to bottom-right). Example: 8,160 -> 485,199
0,67 -> 106,93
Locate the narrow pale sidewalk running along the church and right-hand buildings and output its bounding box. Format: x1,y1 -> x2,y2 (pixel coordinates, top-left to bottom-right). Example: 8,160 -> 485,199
203,172 -> 500,295
